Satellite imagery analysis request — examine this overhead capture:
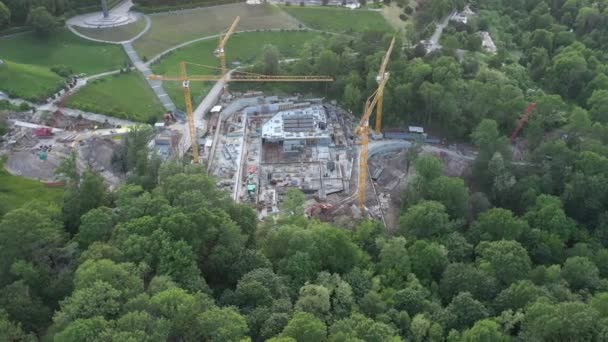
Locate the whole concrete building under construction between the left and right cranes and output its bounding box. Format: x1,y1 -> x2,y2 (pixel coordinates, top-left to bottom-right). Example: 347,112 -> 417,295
210,96 -> 353,217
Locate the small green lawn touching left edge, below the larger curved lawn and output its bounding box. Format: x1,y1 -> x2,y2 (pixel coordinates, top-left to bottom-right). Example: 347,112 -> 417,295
0,60 -> 65,102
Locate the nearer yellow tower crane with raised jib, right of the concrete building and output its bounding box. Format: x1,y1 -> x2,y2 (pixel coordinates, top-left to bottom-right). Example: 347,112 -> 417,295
355,38 -> 395,209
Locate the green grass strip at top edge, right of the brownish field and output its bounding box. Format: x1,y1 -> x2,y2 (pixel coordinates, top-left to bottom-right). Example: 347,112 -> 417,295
281,6 -> 392,33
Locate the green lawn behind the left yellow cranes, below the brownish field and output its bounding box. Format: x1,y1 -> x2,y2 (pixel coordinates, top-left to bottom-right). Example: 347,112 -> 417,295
152,31 -> 321,110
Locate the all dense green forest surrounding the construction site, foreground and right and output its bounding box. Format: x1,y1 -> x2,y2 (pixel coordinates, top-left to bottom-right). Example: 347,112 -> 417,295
5,0 -> 608,342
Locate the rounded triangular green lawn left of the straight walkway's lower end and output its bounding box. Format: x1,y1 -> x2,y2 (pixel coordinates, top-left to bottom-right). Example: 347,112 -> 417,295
66,72 -> 164,122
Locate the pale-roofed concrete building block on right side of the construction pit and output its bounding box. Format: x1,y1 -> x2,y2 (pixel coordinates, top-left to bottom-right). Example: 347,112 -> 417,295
258,104 -> 352,213
